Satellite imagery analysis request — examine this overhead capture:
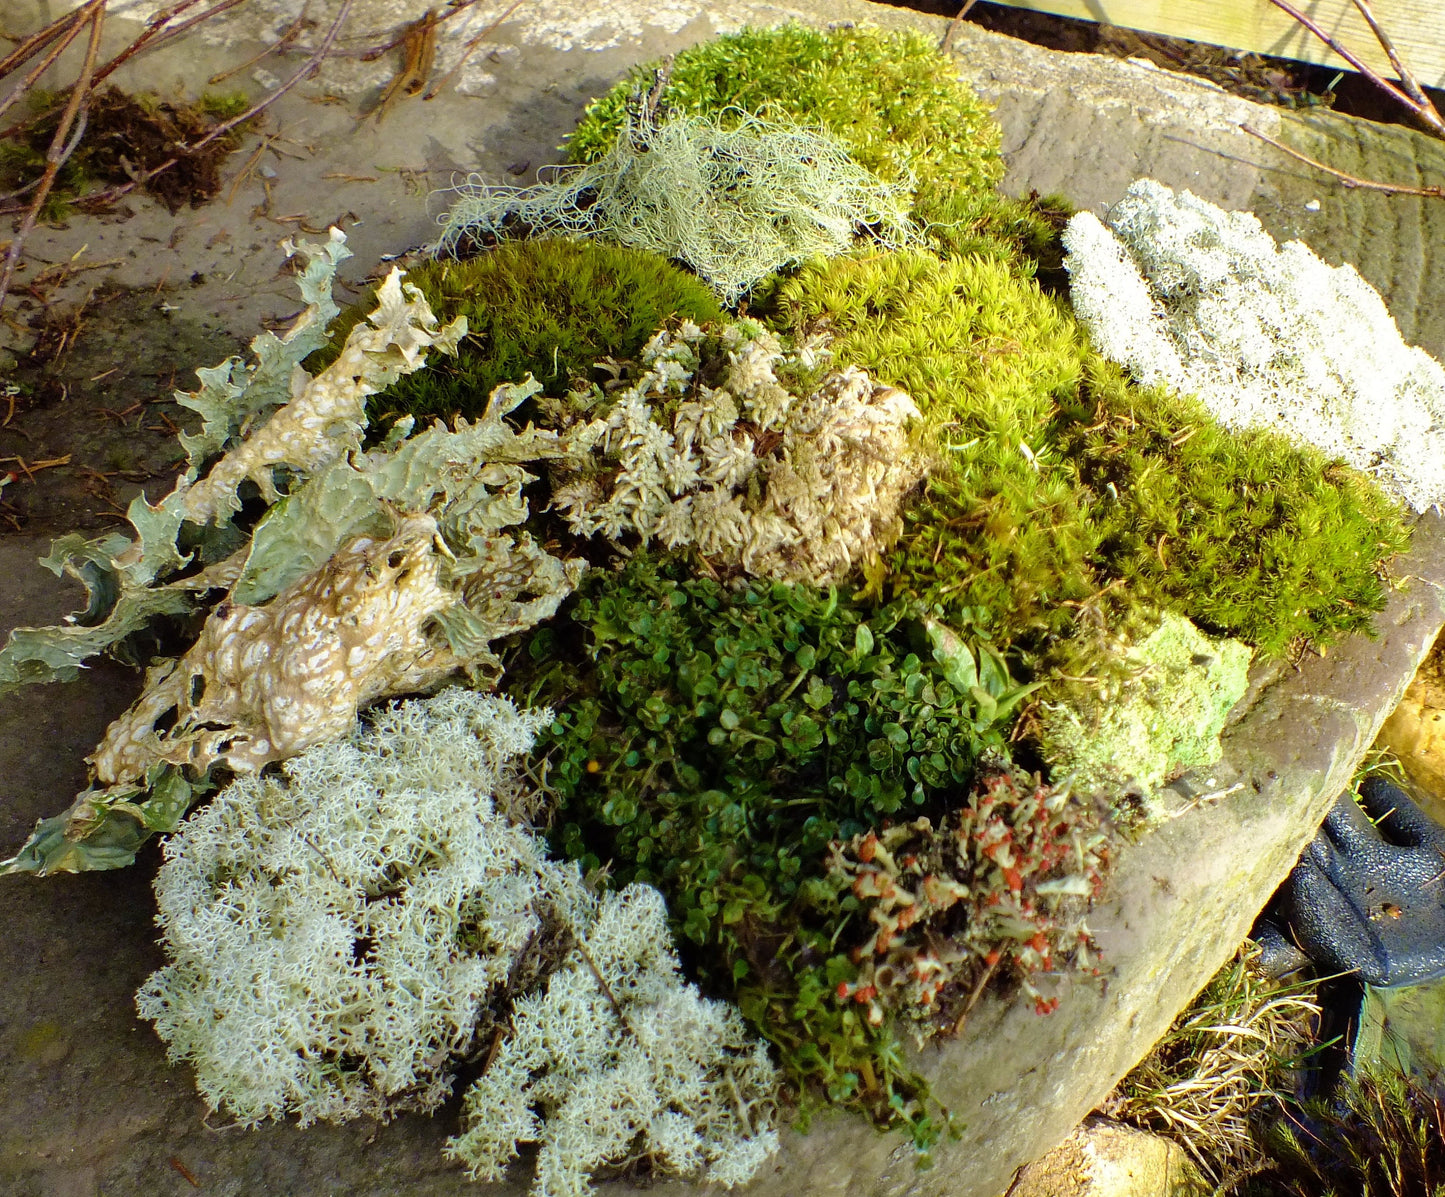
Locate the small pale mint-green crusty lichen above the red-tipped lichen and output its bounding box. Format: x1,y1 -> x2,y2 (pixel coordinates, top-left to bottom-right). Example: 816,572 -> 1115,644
1040,613 -> 1251,814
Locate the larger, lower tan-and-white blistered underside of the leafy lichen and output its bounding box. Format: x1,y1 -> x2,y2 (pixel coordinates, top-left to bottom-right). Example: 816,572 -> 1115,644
91,515 -> 460,785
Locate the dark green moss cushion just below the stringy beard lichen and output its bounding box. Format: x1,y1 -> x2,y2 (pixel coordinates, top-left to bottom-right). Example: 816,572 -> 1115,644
308,239 -> 723,426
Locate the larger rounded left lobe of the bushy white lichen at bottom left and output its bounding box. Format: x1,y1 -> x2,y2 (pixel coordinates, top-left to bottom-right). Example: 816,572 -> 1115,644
137,688 -> 594,1125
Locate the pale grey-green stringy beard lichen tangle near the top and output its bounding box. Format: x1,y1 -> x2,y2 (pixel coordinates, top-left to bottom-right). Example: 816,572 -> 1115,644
438,114 -> 916,304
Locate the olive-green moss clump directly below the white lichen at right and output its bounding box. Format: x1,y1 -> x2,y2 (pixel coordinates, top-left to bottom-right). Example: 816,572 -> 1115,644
1058,359 -> 1410,656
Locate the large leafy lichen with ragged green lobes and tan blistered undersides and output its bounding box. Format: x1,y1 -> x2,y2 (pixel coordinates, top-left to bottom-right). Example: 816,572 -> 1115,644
0,231 -> 582,873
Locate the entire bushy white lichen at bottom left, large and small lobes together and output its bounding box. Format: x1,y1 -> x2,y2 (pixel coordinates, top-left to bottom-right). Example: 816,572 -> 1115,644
136,688 -> 777,1194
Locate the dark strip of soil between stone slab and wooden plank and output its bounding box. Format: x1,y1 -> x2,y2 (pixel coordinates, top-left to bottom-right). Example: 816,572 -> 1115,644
880,0 -> 1445,126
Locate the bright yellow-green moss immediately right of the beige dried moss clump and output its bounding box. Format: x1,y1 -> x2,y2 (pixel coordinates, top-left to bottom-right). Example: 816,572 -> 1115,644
767,253 -> 1103,643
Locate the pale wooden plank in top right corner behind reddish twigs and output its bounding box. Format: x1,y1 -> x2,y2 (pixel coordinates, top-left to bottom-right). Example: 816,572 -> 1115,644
1000,0 -> 1445,87
